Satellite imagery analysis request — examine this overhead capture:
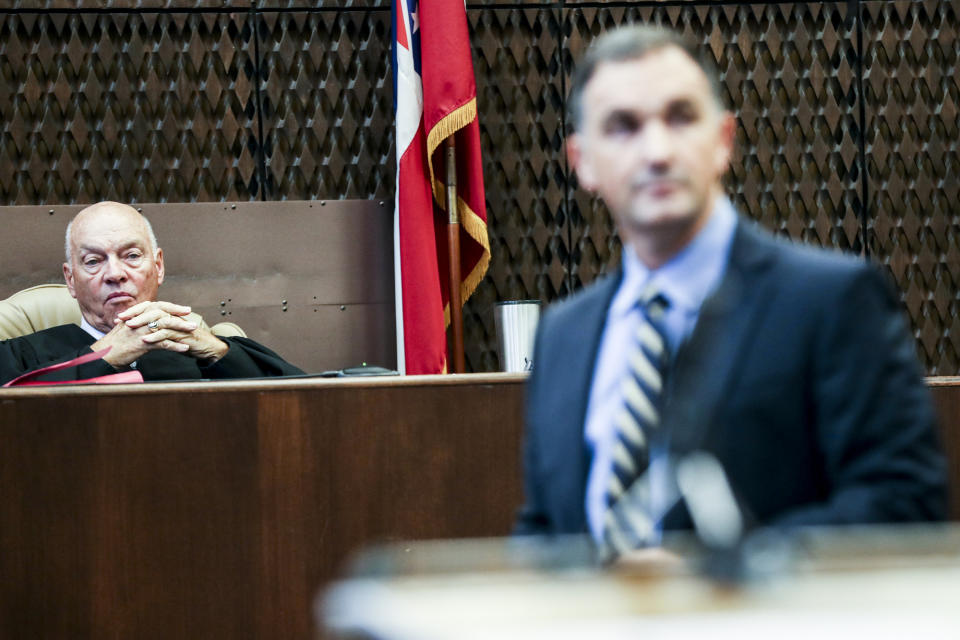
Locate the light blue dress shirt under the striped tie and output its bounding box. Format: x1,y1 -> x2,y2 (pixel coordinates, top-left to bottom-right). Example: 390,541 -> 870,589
584,197 -> 737,542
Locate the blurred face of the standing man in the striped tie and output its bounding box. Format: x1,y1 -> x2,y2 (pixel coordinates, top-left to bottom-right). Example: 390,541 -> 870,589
569,46 -> 734,245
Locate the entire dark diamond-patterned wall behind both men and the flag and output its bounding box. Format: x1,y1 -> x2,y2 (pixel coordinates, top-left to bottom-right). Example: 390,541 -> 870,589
0,0 -> 960,375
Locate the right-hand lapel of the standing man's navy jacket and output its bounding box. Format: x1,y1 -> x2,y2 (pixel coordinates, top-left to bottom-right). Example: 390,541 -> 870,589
664,218 -> 775,453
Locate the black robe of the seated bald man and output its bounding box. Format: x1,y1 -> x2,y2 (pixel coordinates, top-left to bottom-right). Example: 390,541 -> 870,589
0,324 -> 303,384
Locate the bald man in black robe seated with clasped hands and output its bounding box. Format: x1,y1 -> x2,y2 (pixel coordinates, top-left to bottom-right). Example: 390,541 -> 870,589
0,202 -> 302,383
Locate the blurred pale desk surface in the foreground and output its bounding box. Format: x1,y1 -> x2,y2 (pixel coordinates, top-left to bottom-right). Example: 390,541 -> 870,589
315,526 -> 960,640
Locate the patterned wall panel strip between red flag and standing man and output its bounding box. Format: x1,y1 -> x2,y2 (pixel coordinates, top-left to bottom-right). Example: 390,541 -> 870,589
464,9 -> 569,371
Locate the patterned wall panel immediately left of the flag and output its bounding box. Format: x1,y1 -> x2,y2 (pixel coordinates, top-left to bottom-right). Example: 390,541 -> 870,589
258,10 -> 396,200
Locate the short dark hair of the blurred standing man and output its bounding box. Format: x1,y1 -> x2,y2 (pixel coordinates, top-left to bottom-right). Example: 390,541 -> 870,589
567,25 -> 723,130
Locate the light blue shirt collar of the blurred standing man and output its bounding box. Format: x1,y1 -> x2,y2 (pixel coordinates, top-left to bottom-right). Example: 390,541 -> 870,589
610,196 -> 737,315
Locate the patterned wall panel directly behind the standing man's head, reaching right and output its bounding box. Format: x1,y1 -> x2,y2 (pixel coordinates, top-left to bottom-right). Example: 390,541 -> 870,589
564,3 -> 863,285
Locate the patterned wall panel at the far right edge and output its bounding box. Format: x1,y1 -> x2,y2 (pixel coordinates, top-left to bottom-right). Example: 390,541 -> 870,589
862,0 -> 960,375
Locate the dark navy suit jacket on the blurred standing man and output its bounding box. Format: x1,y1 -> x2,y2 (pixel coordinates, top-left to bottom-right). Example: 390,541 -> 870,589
516,220 -> 946,534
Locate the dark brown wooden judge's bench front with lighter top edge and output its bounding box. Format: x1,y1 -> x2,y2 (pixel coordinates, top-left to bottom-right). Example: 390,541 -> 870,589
0,374 -> 960,638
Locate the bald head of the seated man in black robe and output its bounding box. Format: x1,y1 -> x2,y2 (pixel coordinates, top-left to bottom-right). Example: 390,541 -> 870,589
63,202 -> 163,331
